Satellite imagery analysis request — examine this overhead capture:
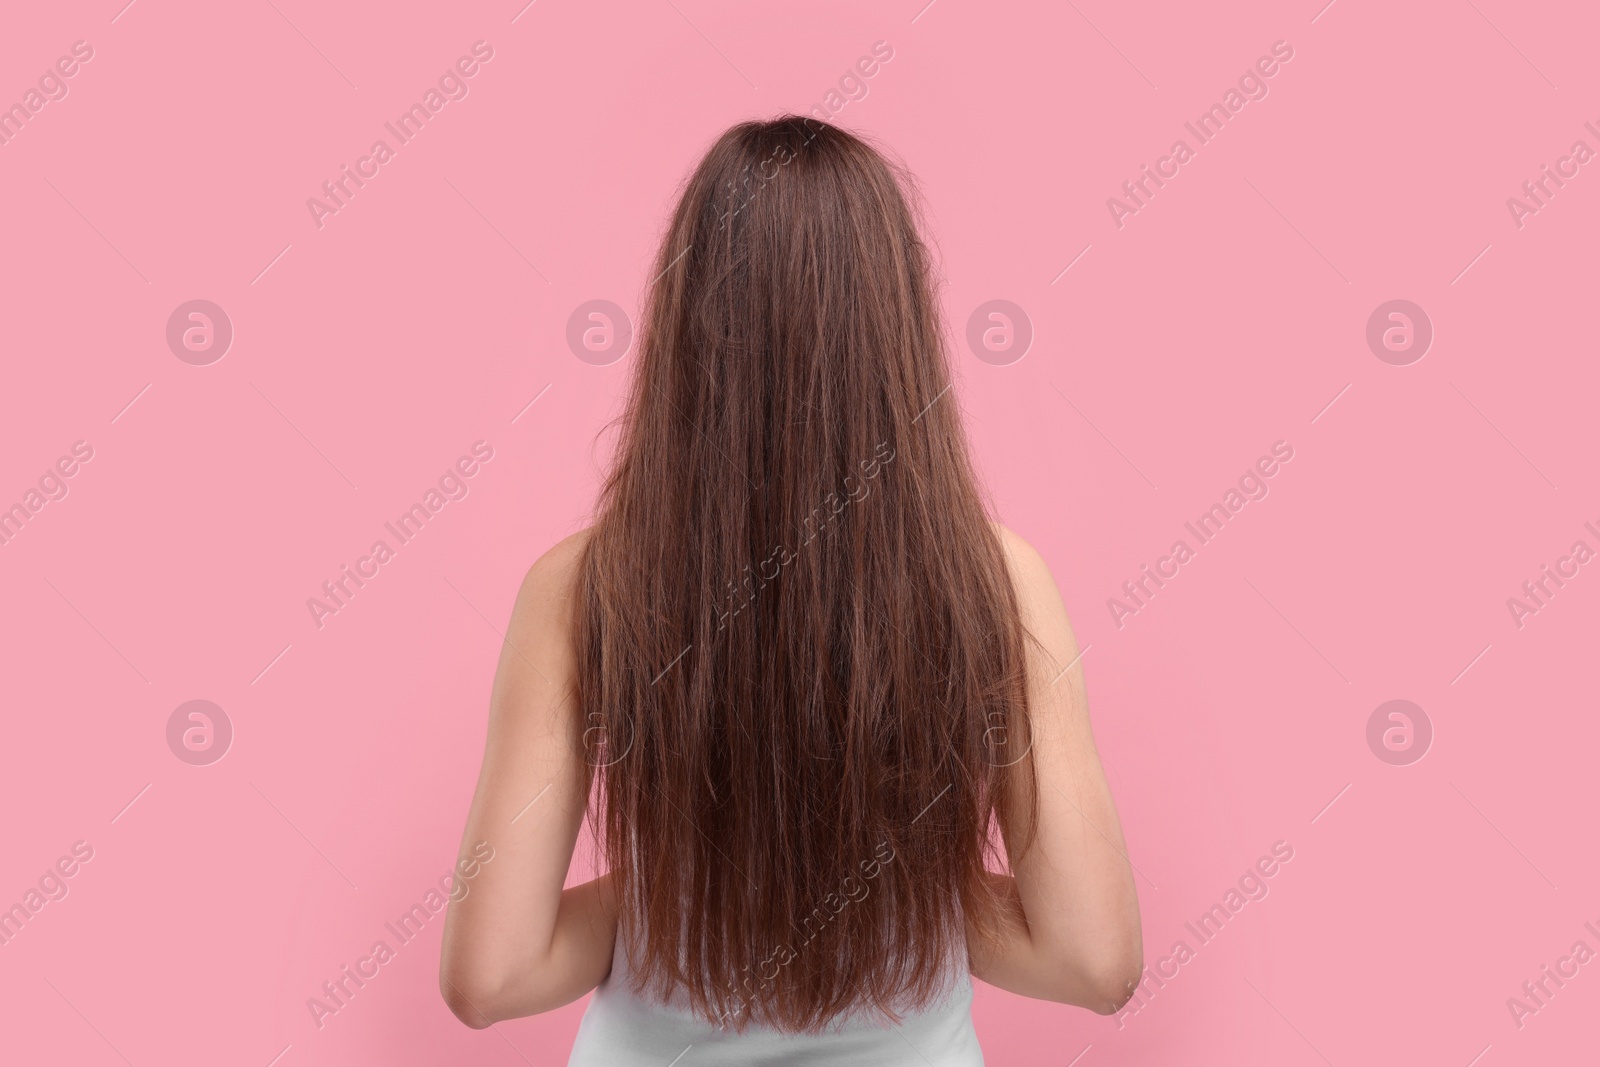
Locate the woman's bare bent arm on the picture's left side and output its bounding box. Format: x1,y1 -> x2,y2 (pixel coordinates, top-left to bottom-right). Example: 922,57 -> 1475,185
438,533 -> 616,1029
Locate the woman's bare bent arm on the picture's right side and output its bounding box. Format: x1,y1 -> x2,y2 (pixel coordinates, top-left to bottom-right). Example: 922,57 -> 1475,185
968,526 -> 1144,1014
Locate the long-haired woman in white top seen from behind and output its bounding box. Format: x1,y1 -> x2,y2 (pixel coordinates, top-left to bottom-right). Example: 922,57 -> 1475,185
440,117 -> 1142,1067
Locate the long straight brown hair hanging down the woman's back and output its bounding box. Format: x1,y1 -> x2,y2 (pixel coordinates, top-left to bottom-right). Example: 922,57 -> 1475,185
576,117 -> 1035,1032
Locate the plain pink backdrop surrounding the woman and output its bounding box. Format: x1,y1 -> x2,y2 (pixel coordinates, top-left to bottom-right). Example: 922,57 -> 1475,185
0,0 -> 1600,1067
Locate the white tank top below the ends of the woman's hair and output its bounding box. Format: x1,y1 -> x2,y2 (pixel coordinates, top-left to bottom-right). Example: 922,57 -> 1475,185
566,937 -> 984,1067
